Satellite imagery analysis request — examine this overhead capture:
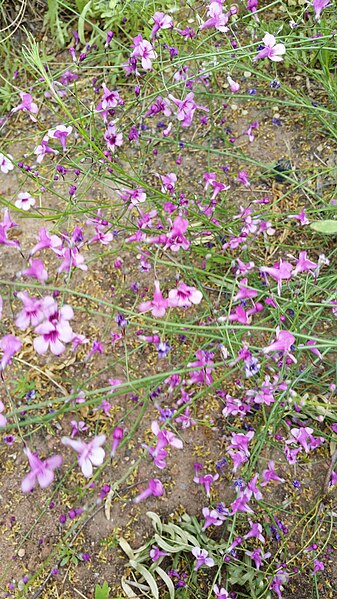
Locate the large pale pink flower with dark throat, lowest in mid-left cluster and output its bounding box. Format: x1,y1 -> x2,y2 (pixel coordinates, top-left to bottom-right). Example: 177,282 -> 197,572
33,305 -> 74,356
